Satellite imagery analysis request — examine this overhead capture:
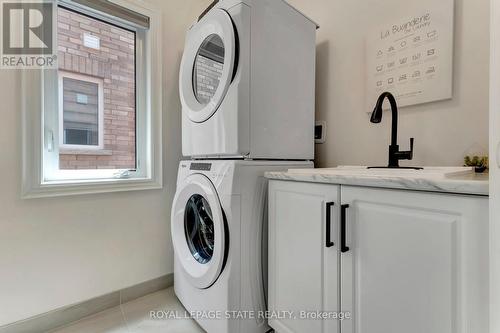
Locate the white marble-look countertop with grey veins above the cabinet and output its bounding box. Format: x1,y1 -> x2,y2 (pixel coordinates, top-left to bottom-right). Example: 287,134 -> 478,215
266,169 -> 489,196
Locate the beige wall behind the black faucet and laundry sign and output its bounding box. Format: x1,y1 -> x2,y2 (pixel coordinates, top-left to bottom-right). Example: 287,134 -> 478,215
289,0 -> 489,166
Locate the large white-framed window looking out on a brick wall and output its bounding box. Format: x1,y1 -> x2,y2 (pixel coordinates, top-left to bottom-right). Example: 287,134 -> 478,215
23,0 -> 161,197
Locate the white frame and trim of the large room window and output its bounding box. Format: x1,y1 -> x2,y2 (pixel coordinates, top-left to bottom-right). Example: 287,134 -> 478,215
21,0 -> 163,199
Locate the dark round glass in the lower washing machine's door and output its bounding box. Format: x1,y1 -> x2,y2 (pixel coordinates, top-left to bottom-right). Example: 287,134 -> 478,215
184,194 -> 215,264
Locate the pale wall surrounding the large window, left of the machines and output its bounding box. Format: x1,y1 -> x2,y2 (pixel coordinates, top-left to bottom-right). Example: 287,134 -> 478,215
0,0 -> 209,326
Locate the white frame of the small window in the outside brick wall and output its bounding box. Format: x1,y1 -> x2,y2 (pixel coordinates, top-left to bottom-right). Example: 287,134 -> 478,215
58,70 -> 104,152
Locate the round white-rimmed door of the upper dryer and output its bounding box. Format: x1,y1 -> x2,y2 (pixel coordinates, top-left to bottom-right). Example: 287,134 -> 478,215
179,9 -> 236,123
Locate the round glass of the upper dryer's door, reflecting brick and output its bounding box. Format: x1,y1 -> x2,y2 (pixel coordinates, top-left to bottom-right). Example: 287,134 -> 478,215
193,34 -> 225,105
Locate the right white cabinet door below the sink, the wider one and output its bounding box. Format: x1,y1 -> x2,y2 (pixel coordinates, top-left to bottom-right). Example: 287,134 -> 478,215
341,187 -> 488,333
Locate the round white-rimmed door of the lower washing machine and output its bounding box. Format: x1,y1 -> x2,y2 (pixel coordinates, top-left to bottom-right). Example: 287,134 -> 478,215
172,174 -> 226,289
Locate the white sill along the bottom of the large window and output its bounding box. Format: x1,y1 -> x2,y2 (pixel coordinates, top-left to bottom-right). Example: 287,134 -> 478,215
22,178 -> 163,199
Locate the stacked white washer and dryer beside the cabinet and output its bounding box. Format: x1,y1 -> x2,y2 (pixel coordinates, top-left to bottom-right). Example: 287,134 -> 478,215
171,0 -> 317,333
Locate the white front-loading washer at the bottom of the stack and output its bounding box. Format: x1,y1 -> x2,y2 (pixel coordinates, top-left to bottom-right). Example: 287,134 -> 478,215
171,160 -> 313,333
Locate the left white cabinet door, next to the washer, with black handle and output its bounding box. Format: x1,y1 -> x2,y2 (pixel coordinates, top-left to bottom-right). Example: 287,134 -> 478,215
269,181 -> 340,333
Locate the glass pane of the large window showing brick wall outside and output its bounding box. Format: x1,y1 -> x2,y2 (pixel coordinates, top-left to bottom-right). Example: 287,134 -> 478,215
57,6 -> 136,170
